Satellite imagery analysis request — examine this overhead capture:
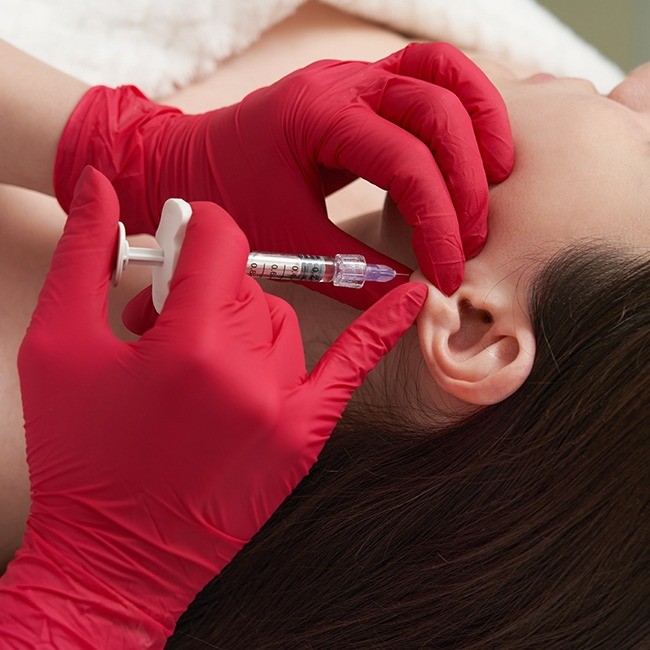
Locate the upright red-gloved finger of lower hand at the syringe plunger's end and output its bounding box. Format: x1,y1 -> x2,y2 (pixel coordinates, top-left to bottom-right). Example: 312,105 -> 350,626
27,166 -> 120,331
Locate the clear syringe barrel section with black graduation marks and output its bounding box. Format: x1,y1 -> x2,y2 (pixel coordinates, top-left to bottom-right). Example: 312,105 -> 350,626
246,251 -> 336,282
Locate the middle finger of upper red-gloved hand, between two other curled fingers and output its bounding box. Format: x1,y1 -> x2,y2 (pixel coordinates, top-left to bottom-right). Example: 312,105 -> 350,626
370,77 -> 488,259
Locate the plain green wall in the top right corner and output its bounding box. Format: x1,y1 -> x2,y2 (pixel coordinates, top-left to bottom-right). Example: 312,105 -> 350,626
536,0 -> 650,71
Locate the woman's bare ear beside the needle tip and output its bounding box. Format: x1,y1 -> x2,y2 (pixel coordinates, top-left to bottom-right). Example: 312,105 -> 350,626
418,272 -> 535,405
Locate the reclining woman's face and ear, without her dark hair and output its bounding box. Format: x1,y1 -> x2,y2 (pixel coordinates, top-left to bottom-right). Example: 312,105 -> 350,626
383,60 -> 650,411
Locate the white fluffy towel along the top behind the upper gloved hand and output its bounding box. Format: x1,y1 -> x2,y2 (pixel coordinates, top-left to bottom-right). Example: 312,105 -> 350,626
0,0 -> 623,98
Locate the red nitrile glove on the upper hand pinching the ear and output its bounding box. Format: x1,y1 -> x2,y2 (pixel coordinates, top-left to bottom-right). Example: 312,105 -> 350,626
54,43 -> 514,308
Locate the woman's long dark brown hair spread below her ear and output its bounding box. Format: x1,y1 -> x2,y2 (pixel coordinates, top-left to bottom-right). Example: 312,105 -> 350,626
168,246 -> 650,650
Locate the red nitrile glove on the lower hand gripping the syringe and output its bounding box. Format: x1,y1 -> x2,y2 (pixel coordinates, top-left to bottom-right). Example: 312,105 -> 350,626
0,168 -> 426,650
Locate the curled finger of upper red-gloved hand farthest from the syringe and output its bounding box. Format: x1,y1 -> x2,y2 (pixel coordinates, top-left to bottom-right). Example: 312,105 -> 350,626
377,43 -> 514,183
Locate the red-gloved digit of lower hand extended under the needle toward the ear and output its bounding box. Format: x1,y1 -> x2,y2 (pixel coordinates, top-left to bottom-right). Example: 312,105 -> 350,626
308,282 -> 427,424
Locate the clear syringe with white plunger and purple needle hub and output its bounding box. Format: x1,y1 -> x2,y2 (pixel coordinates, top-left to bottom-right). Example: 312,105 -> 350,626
113,199 -> 403,313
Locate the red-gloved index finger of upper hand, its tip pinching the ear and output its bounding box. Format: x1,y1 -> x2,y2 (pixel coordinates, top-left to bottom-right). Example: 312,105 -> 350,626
319,105 -> 465,295
